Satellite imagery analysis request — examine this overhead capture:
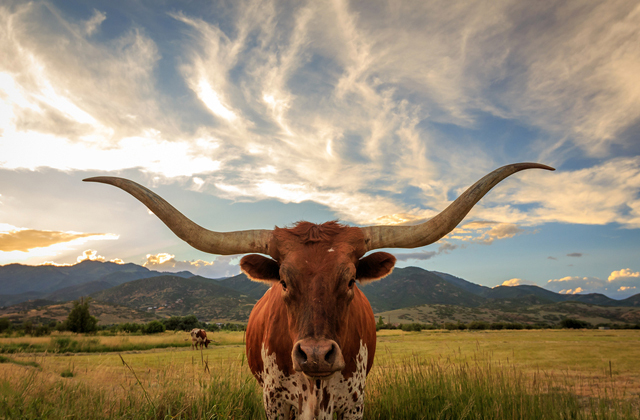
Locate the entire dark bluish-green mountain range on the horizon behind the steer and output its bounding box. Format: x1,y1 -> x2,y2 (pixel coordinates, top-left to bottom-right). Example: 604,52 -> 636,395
0,261 -> 640,322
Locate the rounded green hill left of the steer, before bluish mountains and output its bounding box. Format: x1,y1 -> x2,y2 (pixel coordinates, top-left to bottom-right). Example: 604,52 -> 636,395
91,275 -> 256,321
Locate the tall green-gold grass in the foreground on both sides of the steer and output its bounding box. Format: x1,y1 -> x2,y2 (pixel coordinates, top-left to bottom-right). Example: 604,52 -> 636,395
0,352 -> 640,420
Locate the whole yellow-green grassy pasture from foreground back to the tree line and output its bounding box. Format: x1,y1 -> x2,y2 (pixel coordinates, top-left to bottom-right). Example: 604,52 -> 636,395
0,330 -> 640,419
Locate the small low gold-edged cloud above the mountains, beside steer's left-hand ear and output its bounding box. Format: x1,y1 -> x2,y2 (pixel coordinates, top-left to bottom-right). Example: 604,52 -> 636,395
142,253 -> 240,278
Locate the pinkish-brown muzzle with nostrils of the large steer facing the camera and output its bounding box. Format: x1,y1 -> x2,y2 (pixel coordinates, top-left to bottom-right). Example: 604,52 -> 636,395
291,338 -> 344,378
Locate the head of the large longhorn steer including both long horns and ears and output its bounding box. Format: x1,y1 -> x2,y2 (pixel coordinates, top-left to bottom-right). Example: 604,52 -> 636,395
85,163 -> 553,379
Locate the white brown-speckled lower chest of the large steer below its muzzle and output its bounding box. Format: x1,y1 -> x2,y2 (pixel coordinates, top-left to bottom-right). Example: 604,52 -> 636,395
261,340 -> 369,420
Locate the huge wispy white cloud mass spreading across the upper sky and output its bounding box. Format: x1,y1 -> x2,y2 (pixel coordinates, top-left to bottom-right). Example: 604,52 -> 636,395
0,0 -> 640,233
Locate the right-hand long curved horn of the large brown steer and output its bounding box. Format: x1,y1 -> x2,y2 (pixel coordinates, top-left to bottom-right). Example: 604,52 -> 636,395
362,163 -> 555,251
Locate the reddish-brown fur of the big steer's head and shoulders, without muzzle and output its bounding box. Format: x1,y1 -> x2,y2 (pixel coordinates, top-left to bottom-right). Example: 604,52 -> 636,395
241,221 -> 395,390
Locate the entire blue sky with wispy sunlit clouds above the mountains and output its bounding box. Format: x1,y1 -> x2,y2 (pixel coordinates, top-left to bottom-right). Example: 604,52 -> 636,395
0,0 -> 640,298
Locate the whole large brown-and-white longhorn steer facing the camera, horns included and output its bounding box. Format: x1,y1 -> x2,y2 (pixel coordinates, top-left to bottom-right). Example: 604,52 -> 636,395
85,163 -> 553,419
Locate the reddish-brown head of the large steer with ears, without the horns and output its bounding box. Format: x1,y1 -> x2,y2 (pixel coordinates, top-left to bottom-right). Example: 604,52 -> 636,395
240,222 -> 396,379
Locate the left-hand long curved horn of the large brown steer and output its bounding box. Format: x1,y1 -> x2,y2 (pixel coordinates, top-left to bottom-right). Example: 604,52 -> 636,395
83,176 -> 271,255
